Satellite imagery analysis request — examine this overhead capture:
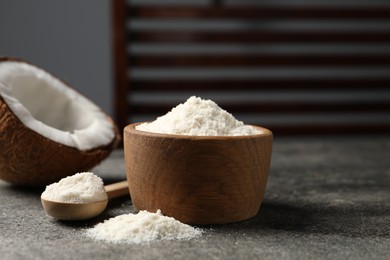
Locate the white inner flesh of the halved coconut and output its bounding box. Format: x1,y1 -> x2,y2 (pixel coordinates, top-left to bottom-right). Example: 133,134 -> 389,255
0,61 -> 115,150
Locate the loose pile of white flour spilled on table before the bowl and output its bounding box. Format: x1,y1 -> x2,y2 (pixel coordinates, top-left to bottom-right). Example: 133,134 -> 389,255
87,210 -> 202,244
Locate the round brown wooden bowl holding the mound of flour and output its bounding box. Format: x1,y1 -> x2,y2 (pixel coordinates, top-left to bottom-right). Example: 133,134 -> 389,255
124,124 -> 272,225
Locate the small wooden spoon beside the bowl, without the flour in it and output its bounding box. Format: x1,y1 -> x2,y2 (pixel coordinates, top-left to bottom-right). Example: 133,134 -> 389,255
41,181 -> 129,220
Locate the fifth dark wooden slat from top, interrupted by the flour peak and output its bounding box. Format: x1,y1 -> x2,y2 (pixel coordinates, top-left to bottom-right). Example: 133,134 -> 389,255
129,101 -> 390,114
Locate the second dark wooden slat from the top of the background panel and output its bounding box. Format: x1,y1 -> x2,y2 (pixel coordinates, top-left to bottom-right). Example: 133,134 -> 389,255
127,31 -> 390,44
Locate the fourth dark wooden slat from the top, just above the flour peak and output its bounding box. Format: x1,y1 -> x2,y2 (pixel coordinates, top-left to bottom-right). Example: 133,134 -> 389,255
129,78 -> 390,91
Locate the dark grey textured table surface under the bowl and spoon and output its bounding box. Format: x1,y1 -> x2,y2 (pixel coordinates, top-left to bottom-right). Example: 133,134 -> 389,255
0,136 -> 390,259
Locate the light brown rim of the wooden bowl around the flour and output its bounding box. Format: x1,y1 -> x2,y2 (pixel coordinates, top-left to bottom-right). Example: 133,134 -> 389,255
123,122 -> 273,140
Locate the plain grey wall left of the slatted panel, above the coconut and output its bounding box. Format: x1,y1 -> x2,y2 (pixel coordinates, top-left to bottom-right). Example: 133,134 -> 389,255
0,0 -> 112,114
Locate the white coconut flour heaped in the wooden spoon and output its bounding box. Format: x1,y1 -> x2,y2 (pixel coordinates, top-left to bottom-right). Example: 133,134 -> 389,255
41,172 -> 107,203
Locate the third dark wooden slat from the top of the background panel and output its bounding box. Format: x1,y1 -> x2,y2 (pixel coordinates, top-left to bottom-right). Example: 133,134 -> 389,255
129,54 -> 390,68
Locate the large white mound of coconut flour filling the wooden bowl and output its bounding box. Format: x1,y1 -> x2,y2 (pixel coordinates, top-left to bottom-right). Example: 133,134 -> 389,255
136,96 -> 262,136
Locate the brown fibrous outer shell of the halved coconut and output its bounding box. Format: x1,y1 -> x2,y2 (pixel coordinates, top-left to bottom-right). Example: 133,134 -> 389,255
0,59 -> 120,187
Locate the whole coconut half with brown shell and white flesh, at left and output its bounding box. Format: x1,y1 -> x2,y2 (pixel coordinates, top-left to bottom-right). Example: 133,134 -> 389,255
0,58 -> 119,186
